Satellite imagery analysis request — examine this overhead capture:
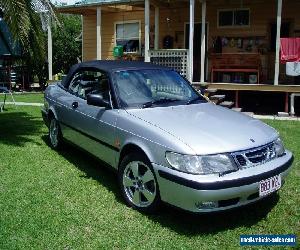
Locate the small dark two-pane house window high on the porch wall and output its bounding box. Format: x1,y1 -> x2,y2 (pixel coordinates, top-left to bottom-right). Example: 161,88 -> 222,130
218,9 -> 250,27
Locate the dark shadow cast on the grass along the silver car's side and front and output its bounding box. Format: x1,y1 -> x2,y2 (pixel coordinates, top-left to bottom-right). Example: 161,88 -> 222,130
42,136 -> 279,236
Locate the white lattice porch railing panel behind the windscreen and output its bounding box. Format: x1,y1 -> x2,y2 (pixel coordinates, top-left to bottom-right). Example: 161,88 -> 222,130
149,49 -> 189,78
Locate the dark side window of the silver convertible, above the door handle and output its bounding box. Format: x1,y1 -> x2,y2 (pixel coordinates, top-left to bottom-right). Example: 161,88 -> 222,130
69,70 -> 110,101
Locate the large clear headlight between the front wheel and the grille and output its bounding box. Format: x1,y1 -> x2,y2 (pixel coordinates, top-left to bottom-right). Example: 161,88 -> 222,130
166,152 -> 237,174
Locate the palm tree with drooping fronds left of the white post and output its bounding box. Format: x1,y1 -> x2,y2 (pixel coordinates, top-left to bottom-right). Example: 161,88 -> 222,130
0,0 -> 57,85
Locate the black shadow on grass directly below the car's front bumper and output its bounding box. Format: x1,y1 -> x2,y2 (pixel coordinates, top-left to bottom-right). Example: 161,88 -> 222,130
150,193 -> 279,236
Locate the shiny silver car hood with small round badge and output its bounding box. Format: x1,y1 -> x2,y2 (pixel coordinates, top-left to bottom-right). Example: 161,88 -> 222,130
127,103 -> 278,155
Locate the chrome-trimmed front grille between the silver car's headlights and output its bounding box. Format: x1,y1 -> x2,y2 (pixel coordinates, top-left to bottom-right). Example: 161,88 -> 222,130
232,143 -> 276,168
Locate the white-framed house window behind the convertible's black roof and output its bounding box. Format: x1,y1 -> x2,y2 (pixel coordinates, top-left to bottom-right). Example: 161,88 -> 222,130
115,21 -> 141,53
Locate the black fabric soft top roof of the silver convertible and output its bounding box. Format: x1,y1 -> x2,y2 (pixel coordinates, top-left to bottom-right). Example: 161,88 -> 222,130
62,60 -> 171,86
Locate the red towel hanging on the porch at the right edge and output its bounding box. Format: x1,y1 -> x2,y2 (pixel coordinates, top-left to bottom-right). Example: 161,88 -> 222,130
280,37 -> 300,64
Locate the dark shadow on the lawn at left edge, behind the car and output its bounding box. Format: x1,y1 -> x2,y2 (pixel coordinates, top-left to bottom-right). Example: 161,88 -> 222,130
0,111 -> 43,146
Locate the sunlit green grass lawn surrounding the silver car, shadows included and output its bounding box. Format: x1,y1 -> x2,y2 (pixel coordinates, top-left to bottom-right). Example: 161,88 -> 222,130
0,106 -> 300,249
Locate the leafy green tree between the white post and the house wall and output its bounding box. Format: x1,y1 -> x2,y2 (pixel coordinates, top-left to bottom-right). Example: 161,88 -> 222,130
52,14 -> 81,74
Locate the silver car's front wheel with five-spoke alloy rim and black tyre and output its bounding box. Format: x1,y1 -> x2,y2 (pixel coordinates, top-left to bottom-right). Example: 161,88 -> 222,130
119,154 -> 161,213
